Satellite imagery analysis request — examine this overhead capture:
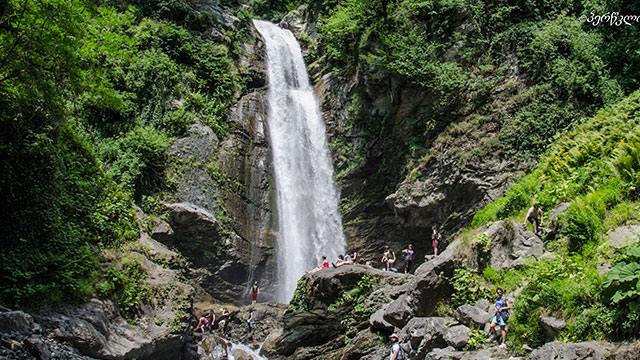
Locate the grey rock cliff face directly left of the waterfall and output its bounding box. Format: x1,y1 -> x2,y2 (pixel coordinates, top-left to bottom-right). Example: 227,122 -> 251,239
153,24 -> 275,303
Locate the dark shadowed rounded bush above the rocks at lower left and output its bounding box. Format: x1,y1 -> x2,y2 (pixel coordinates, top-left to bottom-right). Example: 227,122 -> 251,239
0,125 -> 138,307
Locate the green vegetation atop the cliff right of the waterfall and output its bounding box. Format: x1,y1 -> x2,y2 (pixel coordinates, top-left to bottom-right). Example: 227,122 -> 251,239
284,0 -> 640,165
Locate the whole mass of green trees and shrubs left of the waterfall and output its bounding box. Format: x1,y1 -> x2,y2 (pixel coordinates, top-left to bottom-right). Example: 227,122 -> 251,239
0,0 -> 244,311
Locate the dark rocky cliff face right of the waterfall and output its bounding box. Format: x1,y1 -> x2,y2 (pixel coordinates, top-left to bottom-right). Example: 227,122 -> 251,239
282,7 -> 532,264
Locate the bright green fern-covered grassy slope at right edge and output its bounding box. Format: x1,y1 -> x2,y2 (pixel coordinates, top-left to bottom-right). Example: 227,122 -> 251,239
464,92 -> 640,345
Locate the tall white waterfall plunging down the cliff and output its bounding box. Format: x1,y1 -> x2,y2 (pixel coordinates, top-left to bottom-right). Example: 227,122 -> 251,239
254,20 -> 345,303
